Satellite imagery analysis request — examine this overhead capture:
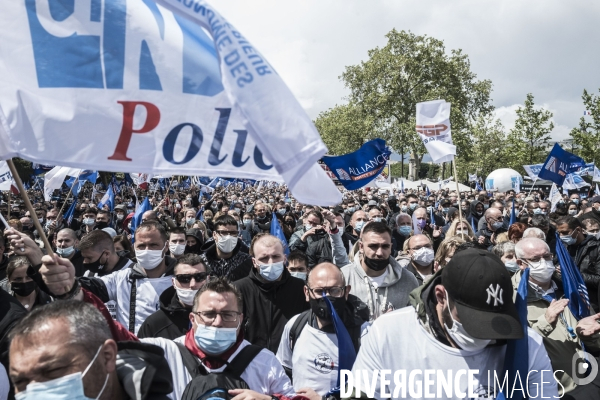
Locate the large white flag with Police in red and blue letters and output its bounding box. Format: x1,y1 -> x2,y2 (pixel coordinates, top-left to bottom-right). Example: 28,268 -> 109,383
0,0 -> 341,205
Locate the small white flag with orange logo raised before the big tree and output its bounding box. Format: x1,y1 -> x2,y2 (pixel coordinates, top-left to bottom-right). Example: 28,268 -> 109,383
417,100 -> 456,163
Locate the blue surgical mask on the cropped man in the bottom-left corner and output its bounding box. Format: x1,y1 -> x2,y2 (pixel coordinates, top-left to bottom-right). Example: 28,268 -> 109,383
15,346 -> 108,400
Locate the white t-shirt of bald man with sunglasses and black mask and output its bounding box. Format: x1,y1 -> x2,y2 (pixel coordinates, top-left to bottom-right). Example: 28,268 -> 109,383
277,315 -> 369,396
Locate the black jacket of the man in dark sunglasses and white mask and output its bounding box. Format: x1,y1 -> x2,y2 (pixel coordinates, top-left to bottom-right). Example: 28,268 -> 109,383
138,286 -> 191,340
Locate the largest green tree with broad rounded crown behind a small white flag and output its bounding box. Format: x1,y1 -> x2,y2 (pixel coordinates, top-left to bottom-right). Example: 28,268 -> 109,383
341,30 -> 493,179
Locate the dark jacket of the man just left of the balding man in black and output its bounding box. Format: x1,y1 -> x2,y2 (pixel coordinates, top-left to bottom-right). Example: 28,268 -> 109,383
200,239 -> 253,282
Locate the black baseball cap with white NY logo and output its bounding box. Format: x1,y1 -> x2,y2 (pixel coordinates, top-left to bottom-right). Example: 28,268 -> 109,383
442,249 -> 523,339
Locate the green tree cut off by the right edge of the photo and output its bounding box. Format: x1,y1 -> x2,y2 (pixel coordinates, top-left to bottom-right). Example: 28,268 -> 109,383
570,89 -> 600,162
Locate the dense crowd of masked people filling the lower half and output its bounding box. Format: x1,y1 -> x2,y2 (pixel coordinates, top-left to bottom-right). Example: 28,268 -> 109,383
0,185 -> 600,400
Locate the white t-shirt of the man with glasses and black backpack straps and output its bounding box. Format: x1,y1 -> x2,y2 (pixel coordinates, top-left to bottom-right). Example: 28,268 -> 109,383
140,336 -> 295,400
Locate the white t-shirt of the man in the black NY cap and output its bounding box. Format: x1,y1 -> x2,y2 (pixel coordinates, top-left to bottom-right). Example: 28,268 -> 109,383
352,307 -> 558,399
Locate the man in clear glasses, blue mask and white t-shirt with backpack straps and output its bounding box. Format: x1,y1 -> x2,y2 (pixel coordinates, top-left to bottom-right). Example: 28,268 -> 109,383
142,278 -> 294,400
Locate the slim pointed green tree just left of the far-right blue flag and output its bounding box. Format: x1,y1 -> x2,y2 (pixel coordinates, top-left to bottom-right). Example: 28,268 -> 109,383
506,93 -> 554,171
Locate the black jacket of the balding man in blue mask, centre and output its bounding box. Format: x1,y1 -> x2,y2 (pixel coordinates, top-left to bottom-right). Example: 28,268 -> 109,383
235,268 -> 309,353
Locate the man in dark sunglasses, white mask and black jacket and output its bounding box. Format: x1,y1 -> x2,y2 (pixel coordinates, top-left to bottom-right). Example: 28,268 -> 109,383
138,254 -> 209,340
